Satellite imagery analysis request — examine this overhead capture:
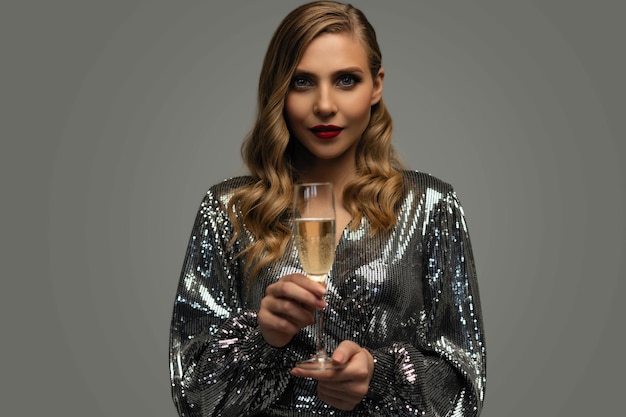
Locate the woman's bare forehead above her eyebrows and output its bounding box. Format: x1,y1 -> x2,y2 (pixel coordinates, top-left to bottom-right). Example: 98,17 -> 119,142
297,32 -> 369,71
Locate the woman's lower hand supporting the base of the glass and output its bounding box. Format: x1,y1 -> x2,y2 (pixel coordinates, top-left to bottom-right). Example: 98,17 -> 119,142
291,340 -> 374,410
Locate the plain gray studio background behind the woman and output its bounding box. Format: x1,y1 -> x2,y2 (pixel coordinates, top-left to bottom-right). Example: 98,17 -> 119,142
0,0 -> 626,417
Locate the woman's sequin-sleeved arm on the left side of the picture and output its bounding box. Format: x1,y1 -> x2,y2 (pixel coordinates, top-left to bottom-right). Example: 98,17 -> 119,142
170,191 -> 292,417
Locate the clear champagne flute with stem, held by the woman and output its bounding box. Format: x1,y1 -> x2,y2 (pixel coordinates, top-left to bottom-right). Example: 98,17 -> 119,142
294,183 -> 340,369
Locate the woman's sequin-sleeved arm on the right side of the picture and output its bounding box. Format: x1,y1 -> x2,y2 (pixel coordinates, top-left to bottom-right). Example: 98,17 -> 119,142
366,190 -> 486,416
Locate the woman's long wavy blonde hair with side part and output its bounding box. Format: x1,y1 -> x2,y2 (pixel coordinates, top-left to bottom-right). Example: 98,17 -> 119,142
228,1 -> 403,279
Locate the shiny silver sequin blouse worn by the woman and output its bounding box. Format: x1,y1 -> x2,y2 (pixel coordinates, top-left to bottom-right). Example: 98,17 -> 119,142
170,171 -> 486,417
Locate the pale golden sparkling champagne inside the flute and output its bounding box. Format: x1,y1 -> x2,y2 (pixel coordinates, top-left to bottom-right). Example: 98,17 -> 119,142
295,219 -> 335,282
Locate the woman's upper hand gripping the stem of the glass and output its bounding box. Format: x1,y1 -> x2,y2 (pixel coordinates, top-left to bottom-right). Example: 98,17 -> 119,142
257,274 -> 326,347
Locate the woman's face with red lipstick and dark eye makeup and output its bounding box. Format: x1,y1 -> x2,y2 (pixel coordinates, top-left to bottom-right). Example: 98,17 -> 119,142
285,33 -> 384,169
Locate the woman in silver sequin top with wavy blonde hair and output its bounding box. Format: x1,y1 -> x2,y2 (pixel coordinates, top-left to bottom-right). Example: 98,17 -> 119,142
170,2 -> 486,417
